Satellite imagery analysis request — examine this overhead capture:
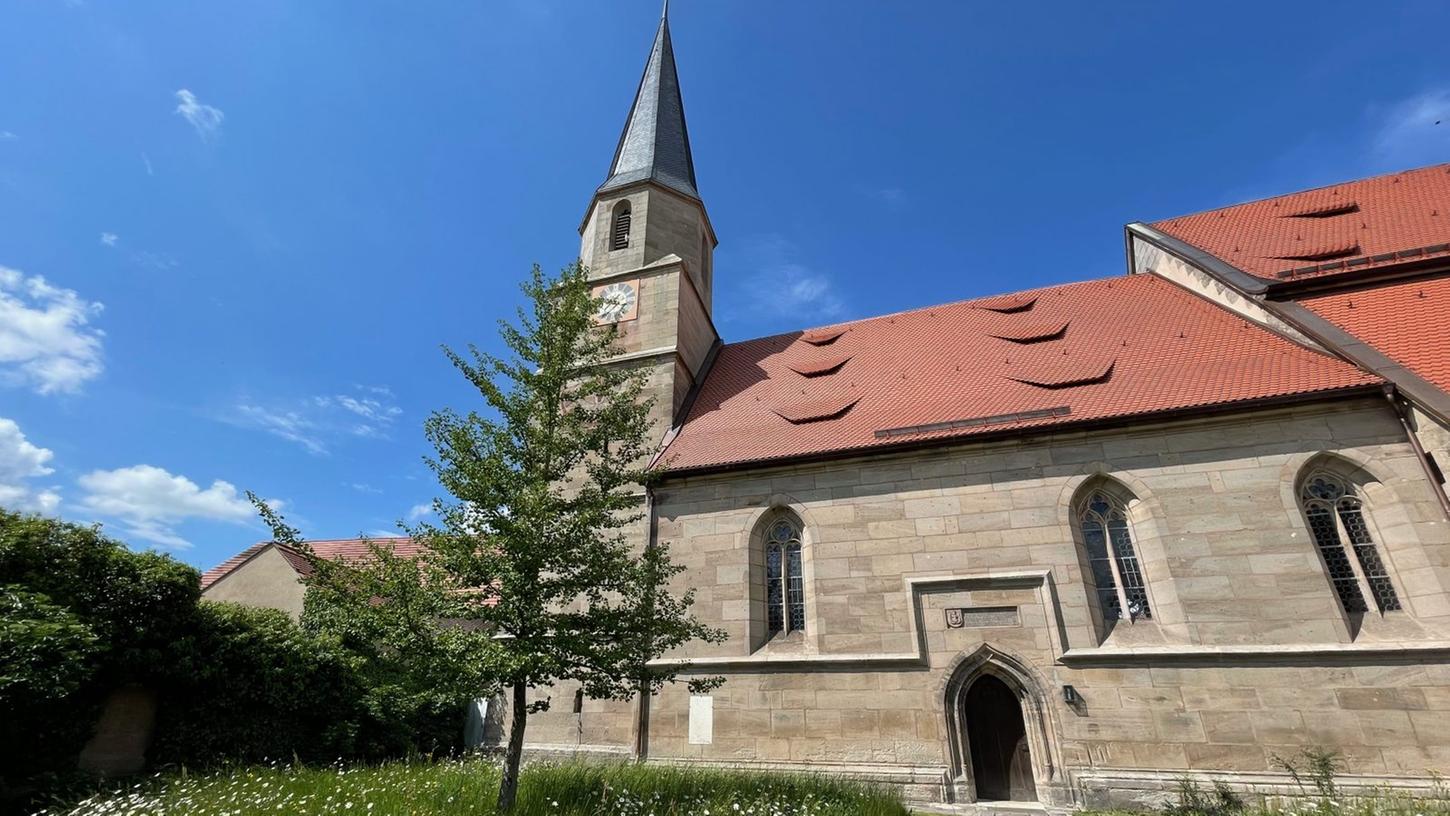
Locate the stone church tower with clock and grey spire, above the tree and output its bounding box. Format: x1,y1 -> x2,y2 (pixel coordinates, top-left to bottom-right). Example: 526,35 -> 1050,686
579,4 -> 719,438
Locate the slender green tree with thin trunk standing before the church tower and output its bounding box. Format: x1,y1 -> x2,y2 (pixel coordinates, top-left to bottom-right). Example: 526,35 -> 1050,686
258,264 -> 724,812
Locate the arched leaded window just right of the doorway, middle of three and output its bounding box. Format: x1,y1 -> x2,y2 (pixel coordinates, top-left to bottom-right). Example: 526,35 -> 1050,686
1077,490 -> 1153,629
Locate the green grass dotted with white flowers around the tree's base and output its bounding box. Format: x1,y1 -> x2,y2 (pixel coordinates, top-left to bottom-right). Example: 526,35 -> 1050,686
34,758 -> 908,816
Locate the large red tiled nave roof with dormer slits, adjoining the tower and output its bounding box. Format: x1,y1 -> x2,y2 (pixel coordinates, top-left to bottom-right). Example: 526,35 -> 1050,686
661,275 -> 1379,470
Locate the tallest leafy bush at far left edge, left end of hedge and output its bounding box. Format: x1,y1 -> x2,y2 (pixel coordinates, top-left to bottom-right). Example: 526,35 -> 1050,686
0,509 -> 200,809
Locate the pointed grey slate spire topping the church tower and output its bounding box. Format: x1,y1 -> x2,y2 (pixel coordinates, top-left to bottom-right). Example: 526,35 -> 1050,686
599,9 -> 700,199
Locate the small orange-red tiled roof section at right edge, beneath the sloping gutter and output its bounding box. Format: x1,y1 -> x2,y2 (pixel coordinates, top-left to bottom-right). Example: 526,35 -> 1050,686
1301,275 -> 1450,391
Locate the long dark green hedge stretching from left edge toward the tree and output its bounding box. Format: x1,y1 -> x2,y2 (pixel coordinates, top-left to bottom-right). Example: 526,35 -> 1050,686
0,509 -> 463,812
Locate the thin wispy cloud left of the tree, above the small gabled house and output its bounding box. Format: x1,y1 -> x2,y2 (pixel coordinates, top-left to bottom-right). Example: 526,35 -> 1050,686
230,386 -> 403,455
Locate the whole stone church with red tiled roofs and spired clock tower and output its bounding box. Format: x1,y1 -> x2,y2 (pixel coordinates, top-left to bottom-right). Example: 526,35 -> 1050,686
206,6 -> 1450,810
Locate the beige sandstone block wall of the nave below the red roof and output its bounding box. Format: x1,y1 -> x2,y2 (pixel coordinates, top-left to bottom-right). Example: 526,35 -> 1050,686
632,399 -> 1450,804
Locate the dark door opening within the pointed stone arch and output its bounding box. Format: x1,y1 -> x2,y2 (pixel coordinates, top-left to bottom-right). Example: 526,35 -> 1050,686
961,674 -> 1037,802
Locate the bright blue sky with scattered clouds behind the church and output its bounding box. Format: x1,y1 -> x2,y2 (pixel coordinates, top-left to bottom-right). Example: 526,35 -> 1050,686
0,0 -> 1450,567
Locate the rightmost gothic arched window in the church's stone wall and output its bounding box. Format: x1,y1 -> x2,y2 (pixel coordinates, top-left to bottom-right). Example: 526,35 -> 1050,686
1299,471 -> 1399,612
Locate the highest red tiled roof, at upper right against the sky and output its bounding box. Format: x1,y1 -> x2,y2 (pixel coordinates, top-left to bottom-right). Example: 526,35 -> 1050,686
1153,164 -> 1450,281
